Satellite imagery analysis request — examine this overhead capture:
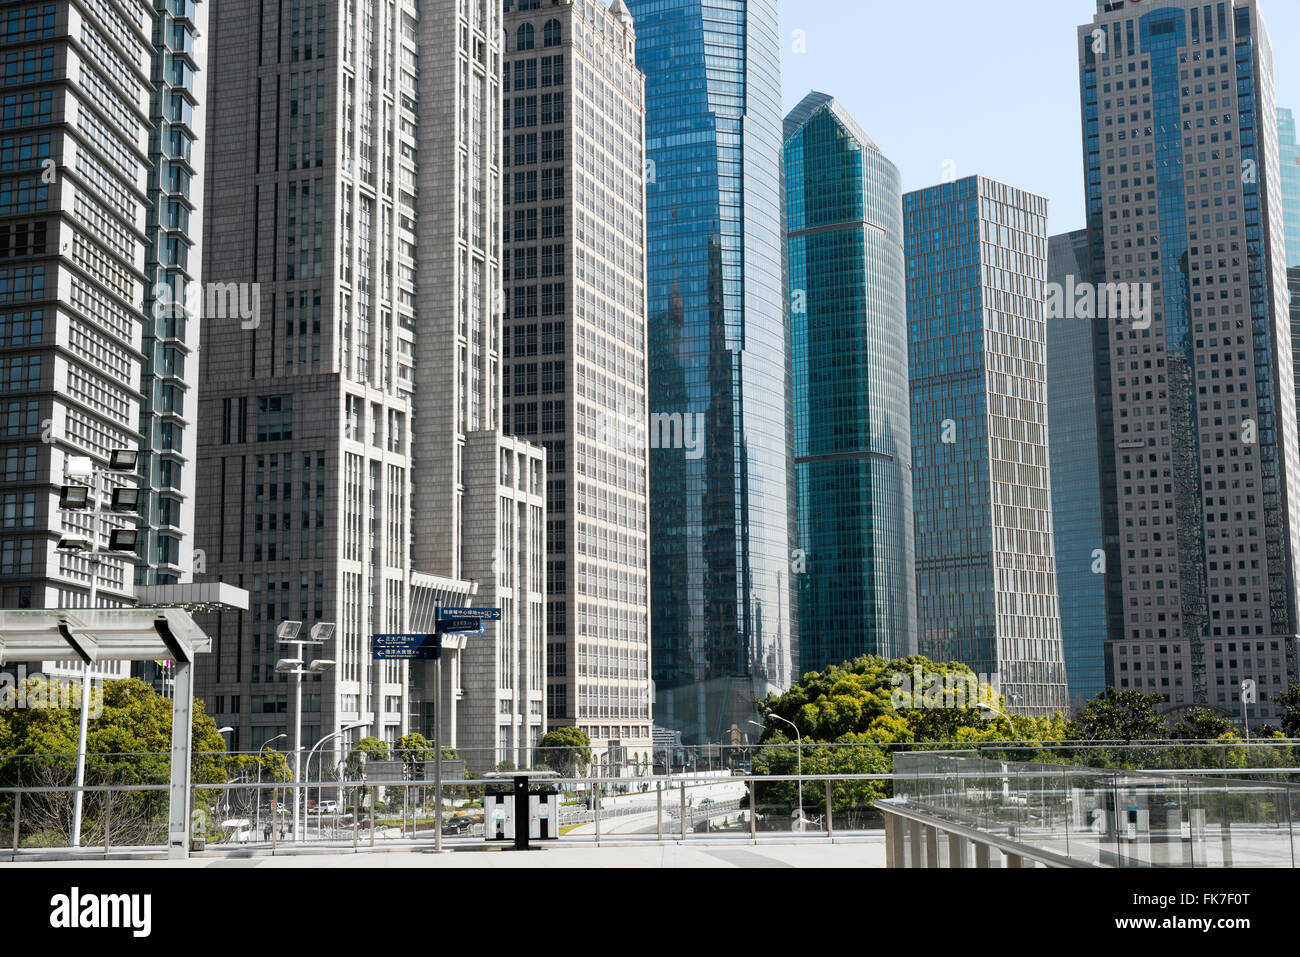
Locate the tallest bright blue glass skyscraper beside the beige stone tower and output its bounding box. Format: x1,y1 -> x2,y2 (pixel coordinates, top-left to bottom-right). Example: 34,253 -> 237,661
627,0 -> 797,744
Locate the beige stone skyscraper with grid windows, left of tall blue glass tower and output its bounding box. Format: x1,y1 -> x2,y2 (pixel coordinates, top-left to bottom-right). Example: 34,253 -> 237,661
502,0 -> 651,771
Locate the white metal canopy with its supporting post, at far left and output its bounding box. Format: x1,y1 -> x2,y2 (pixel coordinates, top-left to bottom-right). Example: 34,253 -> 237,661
0,607 -> 212,858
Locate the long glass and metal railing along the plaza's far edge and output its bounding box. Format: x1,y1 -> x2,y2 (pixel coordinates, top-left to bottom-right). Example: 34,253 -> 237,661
0,741 -> 1300,859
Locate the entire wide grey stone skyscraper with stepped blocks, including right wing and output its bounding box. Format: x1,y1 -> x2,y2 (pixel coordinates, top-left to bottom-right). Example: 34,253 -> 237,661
196,0 -> 545,766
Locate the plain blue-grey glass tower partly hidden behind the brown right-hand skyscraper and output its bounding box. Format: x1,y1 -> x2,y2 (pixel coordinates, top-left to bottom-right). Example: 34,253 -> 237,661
1047,229 -> 1106,706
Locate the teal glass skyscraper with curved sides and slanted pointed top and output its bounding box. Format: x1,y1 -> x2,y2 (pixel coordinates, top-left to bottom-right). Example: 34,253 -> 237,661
785,92 -> 917,672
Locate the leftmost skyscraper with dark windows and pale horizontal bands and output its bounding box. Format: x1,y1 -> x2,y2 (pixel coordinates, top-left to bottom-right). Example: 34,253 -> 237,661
0,1 -> 161,621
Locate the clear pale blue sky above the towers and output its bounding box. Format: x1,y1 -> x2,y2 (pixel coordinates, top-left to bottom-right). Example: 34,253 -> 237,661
780,0 -> 1300,234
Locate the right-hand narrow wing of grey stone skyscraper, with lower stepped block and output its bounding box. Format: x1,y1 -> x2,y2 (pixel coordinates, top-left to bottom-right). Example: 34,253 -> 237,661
407,0 -> 546,766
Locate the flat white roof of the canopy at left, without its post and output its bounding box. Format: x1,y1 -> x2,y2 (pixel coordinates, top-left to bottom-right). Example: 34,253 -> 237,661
0,607 -> 212,664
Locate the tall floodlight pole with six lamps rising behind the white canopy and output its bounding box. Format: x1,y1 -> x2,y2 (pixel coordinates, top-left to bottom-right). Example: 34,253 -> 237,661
59,449 -> 140,848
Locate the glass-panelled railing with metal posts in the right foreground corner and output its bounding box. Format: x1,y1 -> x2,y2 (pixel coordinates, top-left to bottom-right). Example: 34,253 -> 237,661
880,753 -> 1300,867
